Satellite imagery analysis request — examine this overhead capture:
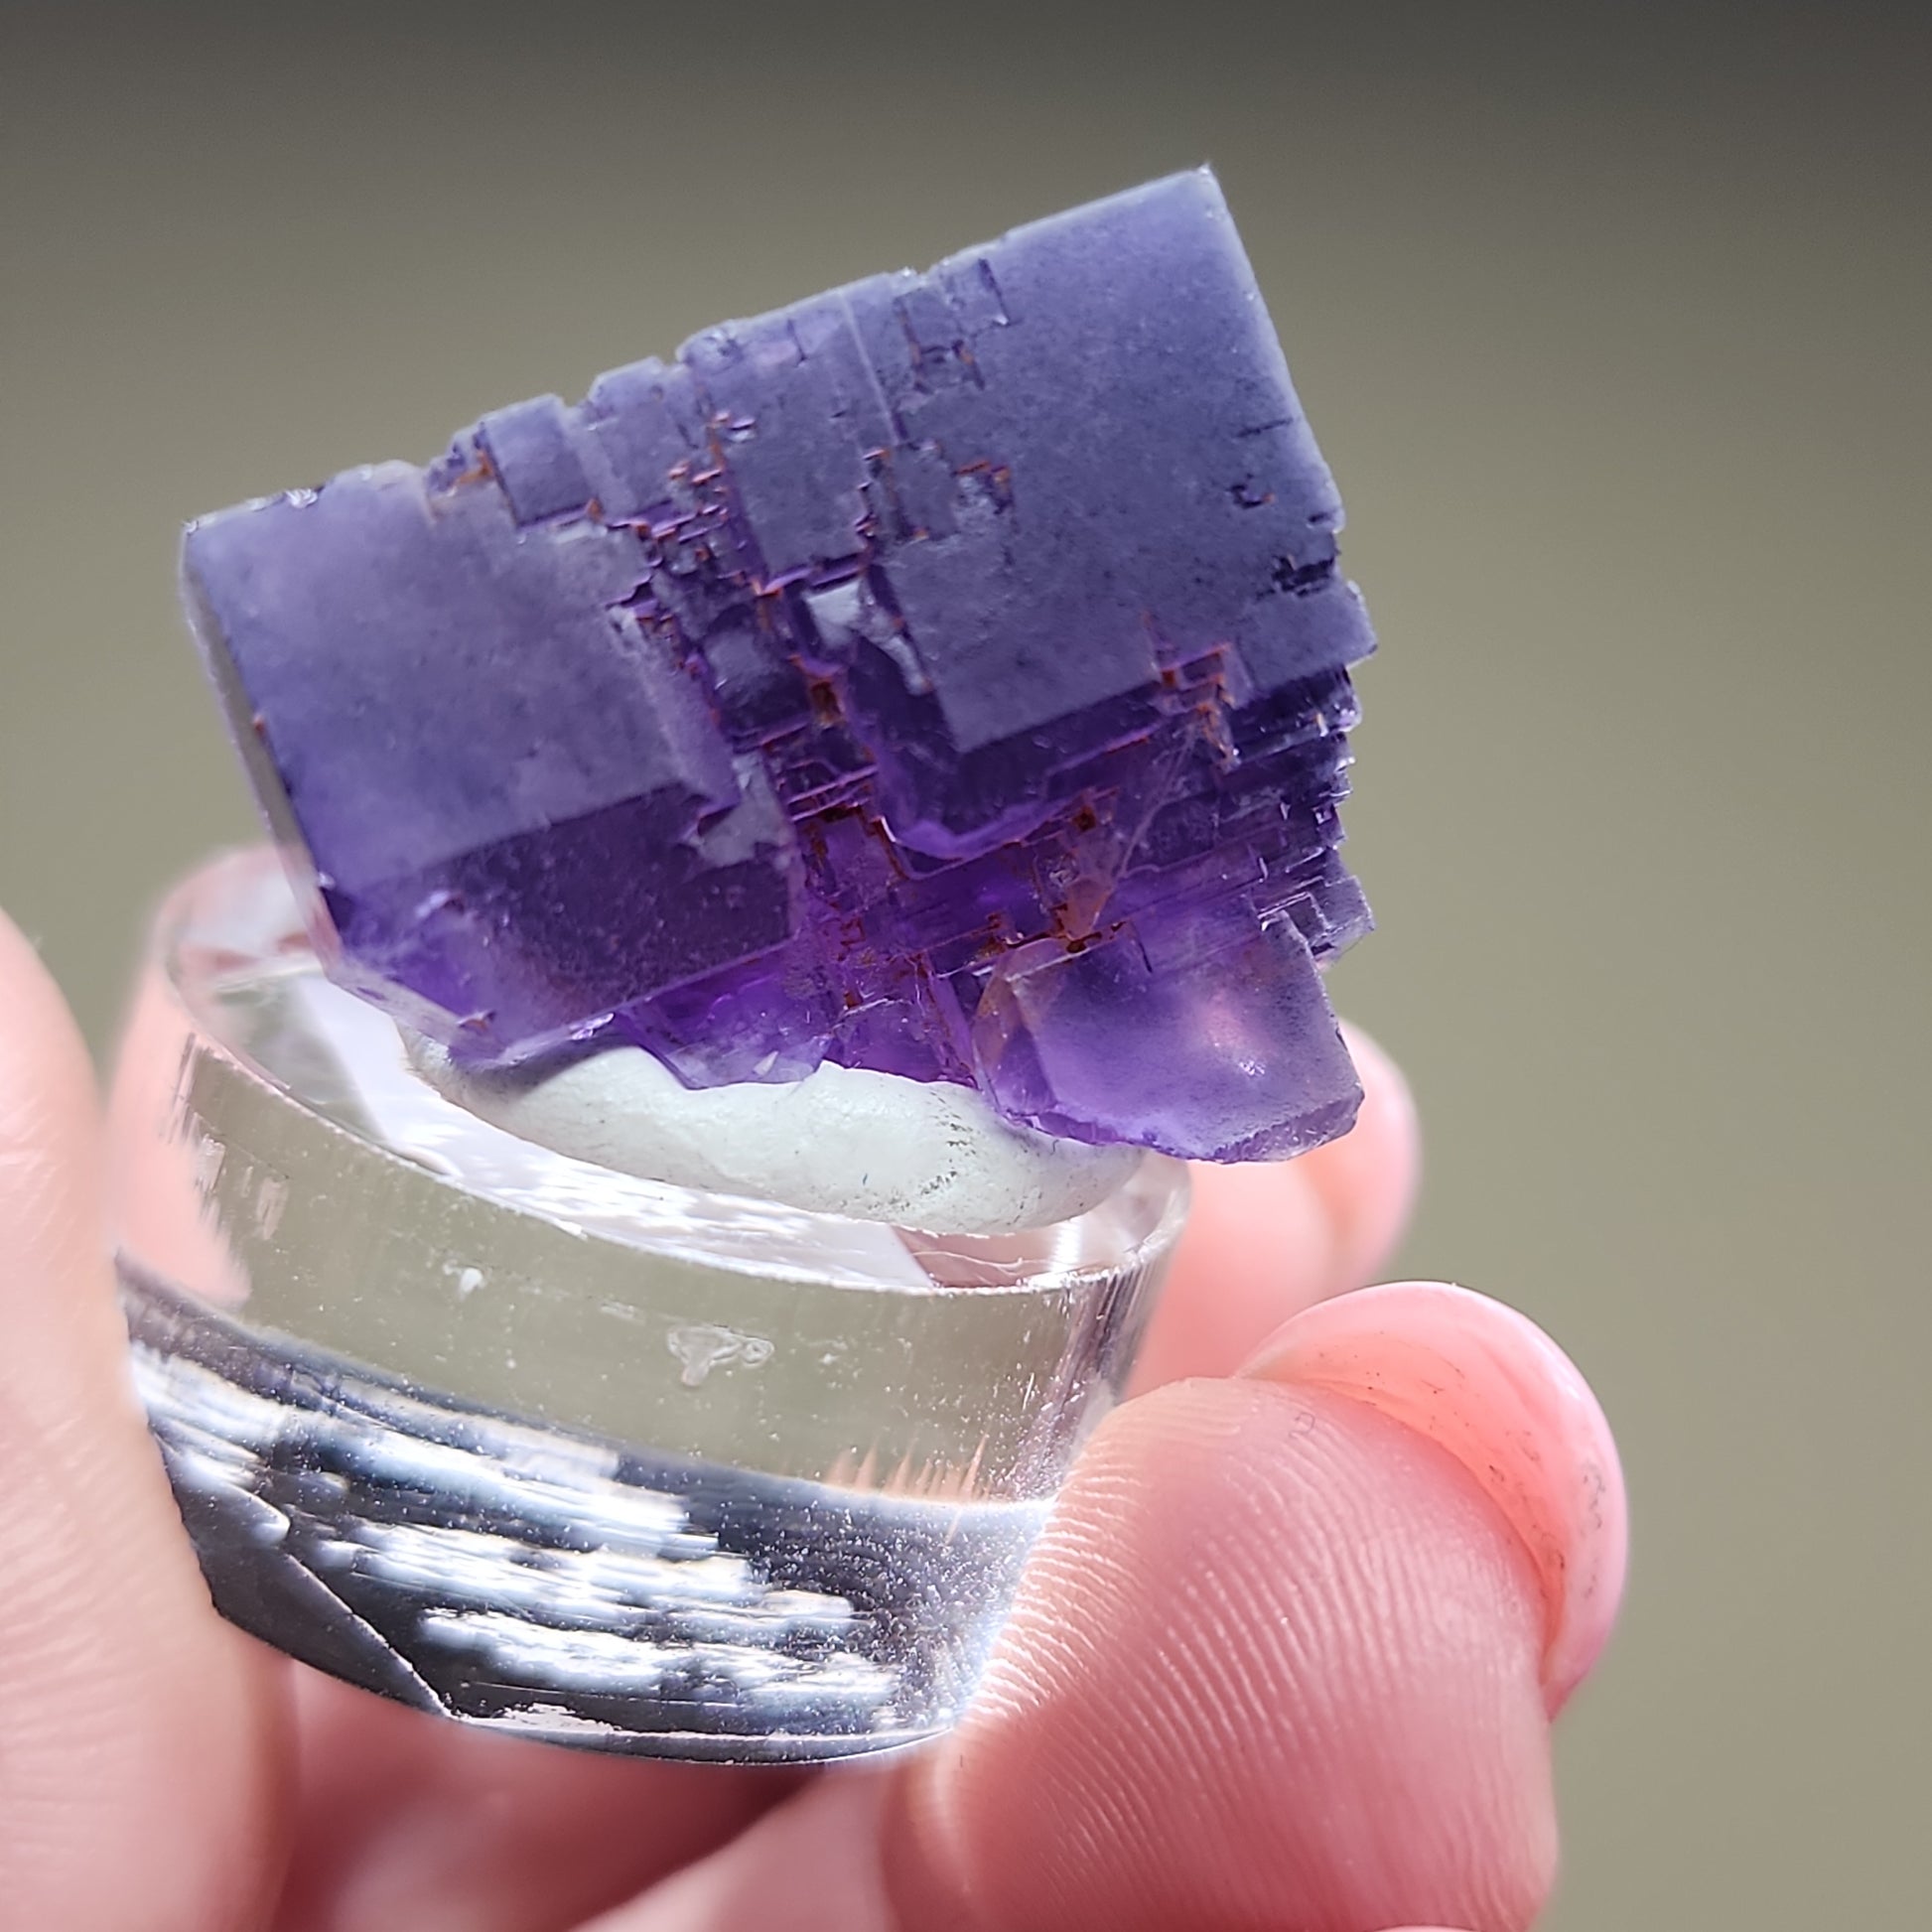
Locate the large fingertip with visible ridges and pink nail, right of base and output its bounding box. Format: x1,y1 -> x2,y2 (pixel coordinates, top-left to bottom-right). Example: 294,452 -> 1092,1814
597,1283 -> 1625,1932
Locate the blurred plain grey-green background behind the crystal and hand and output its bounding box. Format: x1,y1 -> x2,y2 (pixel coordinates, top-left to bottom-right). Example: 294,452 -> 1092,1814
0,0 -> 1932,1932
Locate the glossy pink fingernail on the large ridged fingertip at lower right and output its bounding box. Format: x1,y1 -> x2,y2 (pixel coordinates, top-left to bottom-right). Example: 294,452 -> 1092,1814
1242,1281 -> 1628,1716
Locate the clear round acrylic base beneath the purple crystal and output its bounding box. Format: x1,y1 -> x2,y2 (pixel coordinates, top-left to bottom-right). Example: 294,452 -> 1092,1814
112,852 -> 1186,1760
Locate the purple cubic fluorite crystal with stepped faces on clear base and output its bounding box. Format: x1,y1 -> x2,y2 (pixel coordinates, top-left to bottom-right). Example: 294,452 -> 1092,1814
186,172 -> 1372,1160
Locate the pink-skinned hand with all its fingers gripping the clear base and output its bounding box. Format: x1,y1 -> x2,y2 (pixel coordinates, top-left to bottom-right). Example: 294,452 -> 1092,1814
0,889 -> 1625,1932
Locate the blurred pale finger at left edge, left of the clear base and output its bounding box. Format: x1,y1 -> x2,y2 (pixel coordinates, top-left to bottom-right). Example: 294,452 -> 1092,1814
0,915 -> 280,1932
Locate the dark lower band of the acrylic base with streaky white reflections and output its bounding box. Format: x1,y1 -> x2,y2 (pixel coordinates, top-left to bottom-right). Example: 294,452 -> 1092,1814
124,1277 -> 1047,1760
